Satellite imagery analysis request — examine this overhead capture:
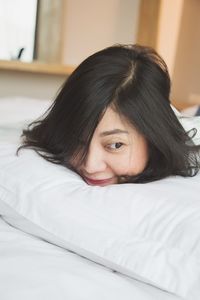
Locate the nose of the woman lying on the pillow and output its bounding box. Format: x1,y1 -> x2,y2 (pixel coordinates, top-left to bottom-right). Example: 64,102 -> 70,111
83,145 -> 107,174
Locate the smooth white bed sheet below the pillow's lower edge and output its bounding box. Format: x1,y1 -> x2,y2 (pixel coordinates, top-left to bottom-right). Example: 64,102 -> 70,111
0,218 -> 181,300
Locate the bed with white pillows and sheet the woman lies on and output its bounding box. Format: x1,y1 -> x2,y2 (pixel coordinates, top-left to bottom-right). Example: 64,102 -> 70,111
0,97 -> 200,300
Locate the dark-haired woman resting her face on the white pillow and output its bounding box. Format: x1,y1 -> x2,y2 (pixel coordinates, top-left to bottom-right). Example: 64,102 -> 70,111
17,45 -> 200,186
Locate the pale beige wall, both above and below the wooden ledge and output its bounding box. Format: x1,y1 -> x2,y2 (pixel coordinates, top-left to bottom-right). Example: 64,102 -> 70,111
0,0 -> 140,99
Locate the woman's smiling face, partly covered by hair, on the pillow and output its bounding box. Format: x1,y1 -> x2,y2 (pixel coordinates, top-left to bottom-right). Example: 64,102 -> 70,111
77,108 -> 148,186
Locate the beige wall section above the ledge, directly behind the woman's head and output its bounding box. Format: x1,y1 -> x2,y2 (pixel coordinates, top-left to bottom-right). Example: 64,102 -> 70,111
63,0 -> 140,65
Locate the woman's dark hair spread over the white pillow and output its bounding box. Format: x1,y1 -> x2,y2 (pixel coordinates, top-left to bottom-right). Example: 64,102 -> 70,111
19,45 -> 200,182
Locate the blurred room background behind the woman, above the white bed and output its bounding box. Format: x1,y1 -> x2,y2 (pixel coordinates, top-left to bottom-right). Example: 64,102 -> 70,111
0,0 -> 200,109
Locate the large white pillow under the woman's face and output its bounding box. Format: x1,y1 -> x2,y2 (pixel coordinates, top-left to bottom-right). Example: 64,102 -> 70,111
0,145 -> 200,297
